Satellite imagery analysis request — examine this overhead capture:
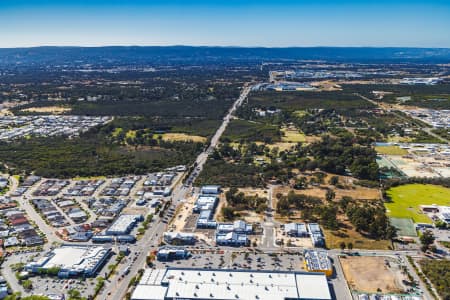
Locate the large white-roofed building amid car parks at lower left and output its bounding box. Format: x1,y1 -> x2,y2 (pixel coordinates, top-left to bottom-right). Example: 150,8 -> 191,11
25,245 -> 111,278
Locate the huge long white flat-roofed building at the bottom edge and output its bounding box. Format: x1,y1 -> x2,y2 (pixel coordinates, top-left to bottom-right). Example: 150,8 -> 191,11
131,267 -> 332,300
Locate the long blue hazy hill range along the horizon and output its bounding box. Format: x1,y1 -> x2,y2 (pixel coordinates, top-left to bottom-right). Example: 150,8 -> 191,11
0,46 -> 450,66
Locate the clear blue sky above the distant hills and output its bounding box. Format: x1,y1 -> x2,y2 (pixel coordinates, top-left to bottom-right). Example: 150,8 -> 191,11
0,0 -> 450,47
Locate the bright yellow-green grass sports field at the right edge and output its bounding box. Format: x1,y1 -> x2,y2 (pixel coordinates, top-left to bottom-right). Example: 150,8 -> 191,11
385,184 -> 450,223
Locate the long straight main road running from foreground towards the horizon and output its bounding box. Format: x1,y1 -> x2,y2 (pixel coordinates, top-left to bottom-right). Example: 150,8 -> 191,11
100,84 -> 251,300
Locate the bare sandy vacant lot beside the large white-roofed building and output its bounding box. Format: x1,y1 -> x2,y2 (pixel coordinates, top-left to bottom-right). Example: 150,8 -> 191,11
340,256 -> 403,293
